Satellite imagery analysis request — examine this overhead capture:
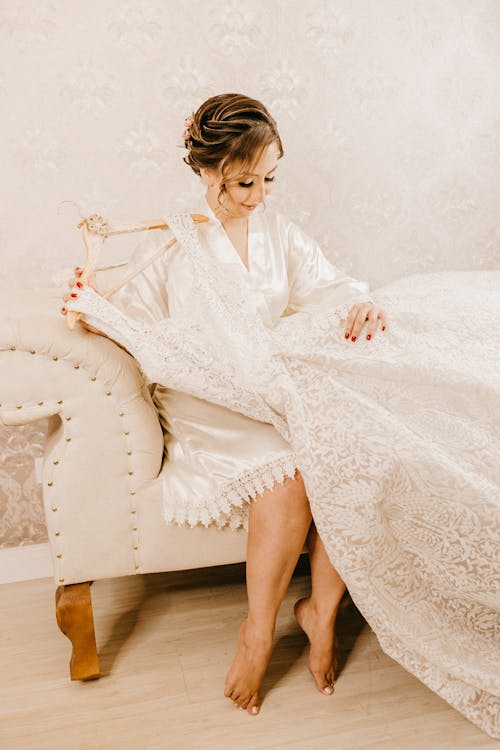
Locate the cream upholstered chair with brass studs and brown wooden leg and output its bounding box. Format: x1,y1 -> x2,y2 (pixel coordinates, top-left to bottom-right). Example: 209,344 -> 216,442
0,285 -> 252,680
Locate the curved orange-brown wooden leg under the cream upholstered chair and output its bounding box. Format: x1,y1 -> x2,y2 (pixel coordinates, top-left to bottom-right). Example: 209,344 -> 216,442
56,581 -> 101,680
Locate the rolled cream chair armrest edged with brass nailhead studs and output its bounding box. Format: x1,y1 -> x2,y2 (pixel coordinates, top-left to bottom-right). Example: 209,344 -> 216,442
0,289 -> 164,583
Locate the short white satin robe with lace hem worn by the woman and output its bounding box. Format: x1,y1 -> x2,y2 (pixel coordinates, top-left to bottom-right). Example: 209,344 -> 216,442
110,198 -> 371,528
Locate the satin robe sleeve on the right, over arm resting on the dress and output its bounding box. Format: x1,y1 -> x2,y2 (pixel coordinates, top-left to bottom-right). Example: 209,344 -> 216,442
285,221 -> 374,314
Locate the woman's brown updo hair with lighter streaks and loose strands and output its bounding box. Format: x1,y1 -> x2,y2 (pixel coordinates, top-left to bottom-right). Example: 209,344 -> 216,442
183,94 -> 284,200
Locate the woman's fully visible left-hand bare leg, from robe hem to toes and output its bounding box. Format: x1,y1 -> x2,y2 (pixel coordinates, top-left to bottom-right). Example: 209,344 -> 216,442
224,470 -> 312,714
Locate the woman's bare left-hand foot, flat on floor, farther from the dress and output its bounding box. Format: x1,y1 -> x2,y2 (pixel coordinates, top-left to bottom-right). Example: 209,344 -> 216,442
224,619 -> 273,715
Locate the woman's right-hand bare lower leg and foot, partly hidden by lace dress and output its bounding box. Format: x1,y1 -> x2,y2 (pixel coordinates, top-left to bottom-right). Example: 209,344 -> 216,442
294,521 -> 346,695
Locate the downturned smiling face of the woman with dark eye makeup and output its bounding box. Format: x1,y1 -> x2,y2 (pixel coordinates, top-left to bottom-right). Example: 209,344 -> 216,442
202,142 -> 279,218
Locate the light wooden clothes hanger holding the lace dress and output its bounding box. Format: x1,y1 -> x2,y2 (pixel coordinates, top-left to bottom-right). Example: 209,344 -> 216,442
66,214 -> 208,330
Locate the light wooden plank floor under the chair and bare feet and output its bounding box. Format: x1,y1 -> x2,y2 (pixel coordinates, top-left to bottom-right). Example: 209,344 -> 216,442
0,558 -> 499,750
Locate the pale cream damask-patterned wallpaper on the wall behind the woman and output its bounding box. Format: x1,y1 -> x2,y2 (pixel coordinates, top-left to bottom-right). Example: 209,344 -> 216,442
0,0 -> 500,546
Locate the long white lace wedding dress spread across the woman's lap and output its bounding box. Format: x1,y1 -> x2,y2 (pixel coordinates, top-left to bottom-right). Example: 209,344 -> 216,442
67,214 -> 500,737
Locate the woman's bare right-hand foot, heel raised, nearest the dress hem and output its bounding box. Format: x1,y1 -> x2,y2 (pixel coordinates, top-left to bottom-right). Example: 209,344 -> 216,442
294,596 -> 337,695
